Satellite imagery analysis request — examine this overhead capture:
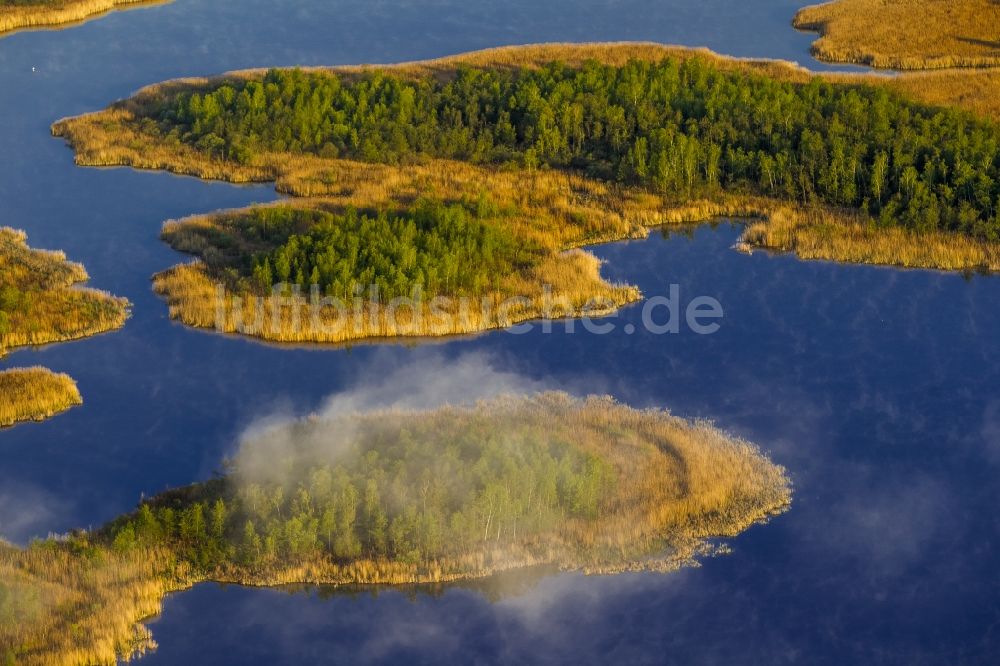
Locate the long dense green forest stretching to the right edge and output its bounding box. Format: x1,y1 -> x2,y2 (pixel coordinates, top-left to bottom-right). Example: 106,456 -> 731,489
152,58 -> 1000,240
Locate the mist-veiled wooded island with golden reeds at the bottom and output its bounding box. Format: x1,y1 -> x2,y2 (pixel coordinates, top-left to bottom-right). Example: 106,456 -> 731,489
0,393 -> 790,664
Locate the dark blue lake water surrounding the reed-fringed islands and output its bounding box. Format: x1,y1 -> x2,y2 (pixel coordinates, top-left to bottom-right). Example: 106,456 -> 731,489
0,0 -> 1000,664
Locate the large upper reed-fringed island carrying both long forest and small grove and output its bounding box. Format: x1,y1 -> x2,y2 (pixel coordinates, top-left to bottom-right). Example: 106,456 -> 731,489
53,45 -> 1000,341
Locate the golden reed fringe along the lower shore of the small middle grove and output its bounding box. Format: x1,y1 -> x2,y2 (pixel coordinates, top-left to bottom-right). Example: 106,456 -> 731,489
153,250 -> 640,343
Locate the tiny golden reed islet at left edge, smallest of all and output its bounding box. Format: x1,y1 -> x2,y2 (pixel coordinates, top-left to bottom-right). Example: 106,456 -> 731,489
0,368 -> 83,427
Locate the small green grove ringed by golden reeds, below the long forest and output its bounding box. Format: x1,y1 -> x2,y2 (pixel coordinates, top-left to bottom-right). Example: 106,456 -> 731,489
237,198 -> 531,302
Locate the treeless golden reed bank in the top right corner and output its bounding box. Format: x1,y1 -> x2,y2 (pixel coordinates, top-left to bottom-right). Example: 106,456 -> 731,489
793,0 -> 1000,70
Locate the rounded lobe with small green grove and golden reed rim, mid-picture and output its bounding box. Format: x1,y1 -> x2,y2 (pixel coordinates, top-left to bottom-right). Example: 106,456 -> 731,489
154,195 -> 639,342
